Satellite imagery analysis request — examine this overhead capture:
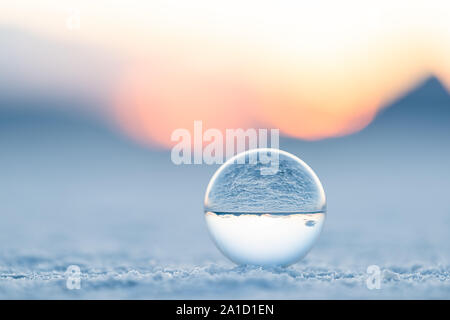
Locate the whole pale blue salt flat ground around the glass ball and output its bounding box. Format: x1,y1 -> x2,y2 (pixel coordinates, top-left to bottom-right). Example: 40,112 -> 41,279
0,132 -> 450,299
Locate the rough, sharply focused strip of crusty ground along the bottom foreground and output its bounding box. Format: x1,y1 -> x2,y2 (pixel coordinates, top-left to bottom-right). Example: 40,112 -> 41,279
0,250 -> 450,299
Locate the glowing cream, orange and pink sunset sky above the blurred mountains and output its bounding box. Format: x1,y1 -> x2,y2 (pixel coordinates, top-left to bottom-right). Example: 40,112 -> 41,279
0,0 -> 450,147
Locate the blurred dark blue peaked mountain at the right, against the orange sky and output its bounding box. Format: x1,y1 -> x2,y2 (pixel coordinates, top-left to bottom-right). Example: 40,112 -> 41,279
280,77 -> 450,154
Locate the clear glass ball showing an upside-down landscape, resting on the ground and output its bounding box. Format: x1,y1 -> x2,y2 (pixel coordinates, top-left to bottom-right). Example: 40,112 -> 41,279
204,148 -> 326,266
